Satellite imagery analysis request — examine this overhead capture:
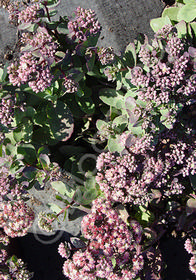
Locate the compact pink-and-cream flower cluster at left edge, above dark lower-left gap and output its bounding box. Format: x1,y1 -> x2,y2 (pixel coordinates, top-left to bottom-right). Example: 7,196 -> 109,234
0,200 -> 34,238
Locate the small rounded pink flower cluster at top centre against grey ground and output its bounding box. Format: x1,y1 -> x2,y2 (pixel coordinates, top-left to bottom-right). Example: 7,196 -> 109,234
68,7 -> 101,42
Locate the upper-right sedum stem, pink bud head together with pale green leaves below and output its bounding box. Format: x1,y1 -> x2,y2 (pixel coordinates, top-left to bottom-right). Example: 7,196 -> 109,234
97,22 -> 195,152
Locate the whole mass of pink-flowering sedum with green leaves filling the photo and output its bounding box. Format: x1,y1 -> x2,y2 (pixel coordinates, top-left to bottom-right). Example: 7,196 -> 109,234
0,0 -> 196,280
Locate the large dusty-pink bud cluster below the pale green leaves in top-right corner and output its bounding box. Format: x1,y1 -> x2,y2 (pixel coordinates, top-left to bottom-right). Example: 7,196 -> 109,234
131,25 -> 196,110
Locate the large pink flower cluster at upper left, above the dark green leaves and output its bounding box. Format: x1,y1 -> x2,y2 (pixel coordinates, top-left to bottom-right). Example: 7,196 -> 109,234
8,27 -> 57,93
